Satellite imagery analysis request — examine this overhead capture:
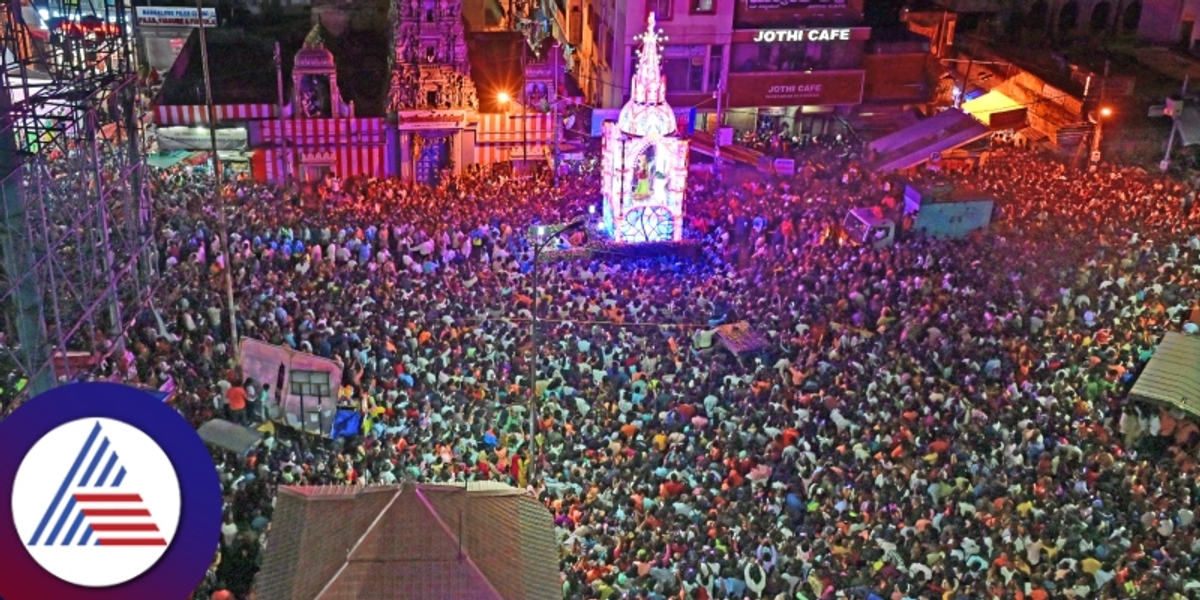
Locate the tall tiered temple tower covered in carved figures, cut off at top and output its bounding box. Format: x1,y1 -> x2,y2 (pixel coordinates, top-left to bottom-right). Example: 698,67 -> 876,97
388,0 -> 479,113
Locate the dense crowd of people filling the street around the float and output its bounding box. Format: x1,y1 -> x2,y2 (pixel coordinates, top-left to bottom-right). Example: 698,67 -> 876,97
2,142 -> 1200,600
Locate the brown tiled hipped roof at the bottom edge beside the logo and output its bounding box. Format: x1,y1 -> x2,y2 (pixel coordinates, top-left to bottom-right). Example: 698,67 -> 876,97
258,484 -> 562,600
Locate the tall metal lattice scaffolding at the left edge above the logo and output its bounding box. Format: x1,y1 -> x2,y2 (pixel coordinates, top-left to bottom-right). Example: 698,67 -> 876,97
0,0 -> 156,394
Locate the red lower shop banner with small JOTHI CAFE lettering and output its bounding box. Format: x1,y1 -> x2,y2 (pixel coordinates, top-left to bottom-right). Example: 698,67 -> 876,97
730,71 -> 865,108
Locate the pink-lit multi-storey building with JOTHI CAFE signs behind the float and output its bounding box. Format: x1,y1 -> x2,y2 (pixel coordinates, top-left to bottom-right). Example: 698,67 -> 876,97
568,0 -> 929,136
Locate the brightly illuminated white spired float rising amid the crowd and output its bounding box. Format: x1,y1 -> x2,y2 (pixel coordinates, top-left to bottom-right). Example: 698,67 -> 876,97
602,13 -> 688,242
